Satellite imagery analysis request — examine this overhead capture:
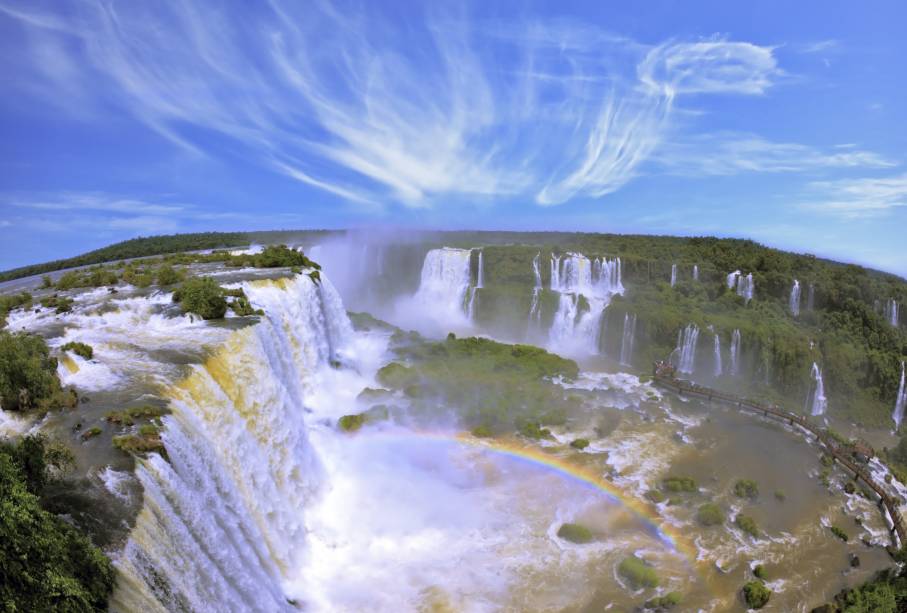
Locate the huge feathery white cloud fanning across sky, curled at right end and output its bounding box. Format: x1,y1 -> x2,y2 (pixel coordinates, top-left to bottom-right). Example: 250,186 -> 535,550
0,0 -> 783,207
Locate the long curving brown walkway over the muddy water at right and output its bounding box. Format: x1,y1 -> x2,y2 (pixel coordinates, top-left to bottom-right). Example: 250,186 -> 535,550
653,373 -> 907,549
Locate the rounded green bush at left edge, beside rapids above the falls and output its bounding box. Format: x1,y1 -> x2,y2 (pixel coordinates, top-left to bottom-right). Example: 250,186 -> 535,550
0,331 -> 62,411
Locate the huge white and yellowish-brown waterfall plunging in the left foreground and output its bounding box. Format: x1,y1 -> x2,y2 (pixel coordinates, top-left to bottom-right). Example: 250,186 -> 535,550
111,275 -> 353,611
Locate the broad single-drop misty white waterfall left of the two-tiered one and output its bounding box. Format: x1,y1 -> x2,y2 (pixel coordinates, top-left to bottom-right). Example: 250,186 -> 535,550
415,247 -> 475,321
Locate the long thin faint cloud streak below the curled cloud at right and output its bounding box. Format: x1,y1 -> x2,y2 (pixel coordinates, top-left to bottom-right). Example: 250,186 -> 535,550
654,132 -> 897,176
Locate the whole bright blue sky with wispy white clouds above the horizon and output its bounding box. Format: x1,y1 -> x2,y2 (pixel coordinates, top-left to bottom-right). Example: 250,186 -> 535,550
0,0 -> 907,275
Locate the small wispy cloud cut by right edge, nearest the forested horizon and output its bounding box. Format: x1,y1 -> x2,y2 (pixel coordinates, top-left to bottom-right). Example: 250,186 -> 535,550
801,174 -> 907,219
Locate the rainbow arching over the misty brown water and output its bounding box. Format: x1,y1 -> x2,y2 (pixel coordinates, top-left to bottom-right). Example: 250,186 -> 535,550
369,429 -> 697,566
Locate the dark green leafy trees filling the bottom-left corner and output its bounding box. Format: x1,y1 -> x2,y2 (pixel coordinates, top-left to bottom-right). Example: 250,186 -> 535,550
0,437 -> 114,611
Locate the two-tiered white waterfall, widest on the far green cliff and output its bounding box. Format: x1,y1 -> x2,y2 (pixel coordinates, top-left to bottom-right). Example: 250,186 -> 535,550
548,253 -> 624,353
